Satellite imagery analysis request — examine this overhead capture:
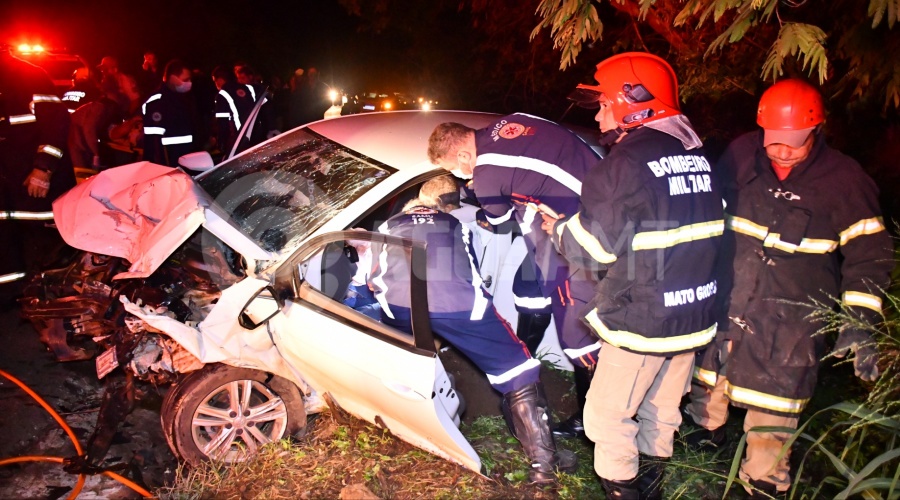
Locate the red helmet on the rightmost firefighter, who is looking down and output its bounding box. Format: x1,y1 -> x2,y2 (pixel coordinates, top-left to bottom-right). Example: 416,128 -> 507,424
756,79 -> 825,130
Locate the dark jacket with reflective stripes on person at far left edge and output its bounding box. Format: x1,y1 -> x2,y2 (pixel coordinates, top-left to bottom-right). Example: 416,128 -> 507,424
0,49 -> 75,207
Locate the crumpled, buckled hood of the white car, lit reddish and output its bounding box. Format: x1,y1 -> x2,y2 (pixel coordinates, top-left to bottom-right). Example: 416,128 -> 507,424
53,162 -> 272,279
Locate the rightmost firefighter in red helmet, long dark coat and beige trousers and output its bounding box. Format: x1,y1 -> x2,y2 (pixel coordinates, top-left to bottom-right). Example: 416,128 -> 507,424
686,79 -> 893,494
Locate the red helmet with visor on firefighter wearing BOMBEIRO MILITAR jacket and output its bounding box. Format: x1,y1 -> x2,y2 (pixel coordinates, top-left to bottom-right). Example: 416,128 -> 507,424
570,52 -> 681,129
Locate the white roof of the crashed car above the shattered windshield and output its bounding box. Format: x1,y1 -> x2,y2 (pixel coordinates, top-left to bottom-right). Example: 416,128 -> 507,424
307,111 -> 501,170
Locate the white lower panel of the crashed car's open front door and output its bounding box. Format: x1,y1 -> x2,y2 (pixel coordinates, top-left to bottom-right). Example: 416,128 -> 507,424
272,294 -> 481,472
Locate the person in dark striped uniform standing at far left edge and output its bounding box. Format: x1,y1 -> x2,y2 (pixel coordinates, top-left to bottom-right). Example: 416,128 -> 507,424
0,46 -> 75,305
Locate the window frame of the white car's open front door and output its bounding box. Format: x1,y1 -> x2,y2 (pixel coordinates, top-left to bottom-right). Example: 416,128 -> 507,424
272,230 -> 437,356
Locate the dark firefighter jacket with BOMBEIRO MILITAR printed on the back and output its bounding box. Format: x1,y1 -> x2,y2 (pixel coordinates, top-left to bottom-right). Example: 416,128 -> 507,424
554,128 -> 724,356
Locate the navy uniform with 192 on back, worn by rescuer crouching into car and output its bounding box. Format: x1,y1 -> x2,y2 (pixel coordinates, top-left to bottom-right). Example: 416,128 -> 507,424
371,207 -> 540,394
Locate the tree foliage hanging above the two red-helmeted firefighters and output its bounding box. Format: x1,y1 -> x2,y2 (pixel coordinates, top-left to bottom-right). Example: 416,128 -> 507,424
531,0 -> 900,110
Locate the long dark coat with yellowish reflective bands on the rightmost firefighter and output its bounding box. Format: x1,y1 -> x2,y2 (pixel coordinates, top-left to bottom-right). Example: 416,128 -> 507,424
695,131 -> 893,416
